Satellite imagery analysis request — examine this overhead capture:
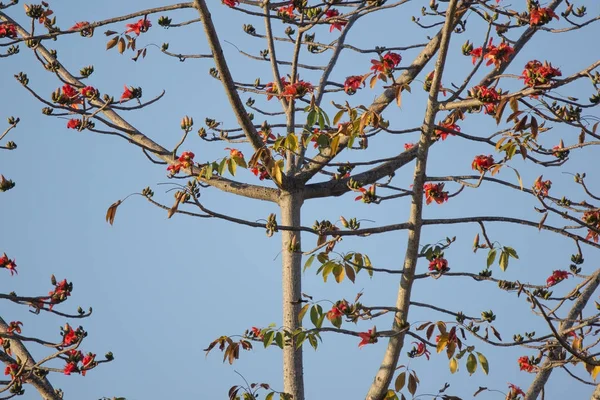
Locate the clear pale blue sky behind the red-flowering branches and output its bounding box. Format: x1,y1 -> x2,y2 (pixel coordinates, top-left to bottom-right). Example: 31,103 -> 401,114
0,0 -> 600,400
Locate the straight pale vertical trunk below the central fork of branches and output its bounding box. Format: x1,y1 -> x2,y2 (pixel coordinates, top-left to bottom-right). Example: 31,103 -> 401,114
279,192 -> 304,400
